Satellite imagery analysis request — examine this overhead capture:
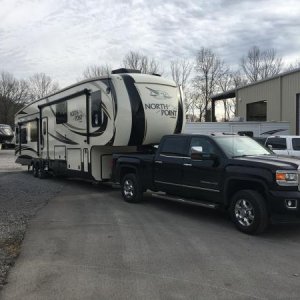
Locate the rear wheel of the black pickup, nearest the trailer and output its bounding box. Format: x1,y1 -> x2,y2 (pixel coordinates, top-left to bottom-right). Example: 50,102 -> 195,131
122,174 -> 143,203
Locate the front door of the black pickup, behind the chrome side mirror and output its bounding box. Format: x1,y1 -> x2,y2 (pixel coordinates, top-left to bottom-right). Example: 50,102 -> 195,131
183,137 -> 224,202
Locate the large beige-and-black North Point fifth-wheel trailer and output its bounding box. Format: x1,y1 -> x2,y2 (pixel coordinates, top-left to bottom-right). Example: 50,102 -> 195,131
15,69 -> 185,181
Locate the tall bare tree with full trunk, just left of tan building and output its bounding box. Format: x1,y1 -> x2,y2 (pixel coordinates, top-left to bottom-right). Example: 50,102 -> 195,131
194,47 -> 225,121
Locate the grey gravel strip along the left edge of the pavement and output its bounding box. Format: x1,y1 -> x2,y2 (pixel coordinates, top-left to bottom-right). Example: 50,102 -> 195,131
0,150 -> 63,289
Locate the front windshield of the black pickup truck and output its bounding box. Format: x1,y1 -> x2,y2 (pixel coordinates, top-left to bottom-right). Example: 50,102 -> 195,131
214,136 -> 272,157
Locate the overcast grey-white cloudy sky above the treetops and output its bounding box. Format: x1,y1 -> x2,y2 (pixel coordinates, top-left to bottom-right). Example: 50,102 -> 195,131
0,0 -> 300,87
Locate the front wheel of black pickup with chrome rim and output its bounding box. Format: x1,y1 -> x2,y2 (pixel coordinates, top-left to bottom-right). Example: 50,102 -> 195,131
230,190 -> 269,234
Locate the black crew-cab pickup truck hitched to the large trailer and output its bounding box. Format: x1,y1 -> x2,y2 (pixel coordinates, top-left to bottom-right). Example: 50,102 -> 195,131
113,134 -> 300,234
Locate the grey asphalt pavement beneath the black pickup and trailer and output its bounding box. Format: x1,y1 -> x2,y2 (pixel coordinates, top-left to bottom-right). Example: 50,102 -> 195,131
0,150 -> 300,299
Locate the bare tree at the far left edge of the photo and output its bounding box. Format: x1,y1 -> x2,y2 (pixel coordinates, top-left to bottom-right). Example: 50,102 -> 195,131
0,72 -> 28,126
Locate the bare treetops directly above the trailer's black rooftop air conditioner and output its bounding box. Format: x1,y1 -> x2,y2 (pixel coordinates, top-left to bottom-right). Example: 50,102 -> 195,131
123,51 -> 163,74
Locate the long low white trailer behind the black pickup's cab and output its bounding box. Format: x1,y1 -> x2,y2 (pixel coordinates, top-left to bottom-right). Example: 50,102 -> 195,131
183,121 -> 290,138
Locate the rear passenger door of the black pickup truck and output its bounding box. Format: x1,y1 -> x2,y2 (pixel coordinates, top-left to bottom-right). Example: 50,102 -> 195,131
154,136 -> 188,194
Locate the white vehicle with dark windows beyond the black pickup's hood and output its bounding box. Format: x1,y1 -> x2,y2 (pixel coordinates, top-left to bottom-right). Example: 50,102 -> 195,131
265,135 -> 300,157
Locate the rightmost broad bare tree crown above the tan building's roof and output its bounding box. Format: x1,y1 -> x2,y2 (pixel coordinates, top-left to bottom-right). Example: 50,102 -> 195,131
241,46 -> 282,82
